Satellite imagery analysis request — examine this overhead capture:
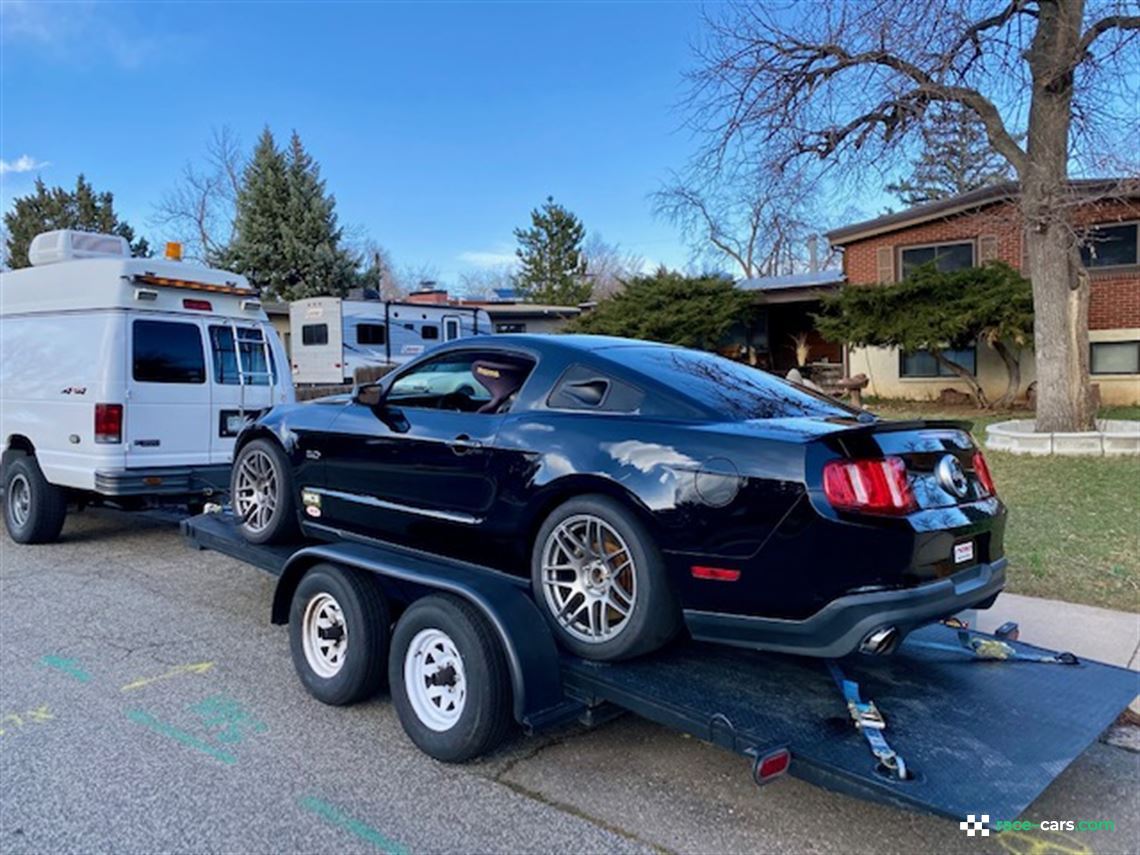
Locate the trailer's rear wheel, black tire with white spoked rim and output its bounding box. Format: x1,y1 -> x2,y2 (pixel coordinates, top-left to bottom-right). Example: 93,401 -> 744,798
388,594 -> 513,763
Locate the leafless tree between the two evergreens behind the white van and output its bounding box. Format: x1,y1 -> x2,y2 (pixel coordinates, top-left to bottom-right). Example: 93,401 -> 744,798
150,125 -> 246,263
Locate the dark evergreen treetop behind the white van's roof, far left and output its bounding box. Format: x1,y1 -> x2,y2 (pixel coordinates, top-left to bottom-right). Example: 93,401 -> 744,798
3,174 -> 150,269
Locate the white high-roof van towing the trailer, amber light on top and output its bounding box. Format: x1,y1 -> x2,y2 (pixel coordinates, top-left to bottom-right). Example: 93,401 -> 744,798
0,230 -> 294,543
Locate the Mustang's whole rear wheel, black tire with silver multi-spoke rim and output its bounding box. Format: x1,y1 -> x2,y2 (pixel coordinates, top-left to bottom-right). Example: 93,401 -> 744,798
530,496 -> 681,661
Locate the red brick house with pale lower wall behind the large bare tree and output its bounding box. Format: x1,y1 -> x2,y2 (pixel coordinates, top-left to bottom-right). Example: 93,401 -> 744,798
827,180 -> 1140,404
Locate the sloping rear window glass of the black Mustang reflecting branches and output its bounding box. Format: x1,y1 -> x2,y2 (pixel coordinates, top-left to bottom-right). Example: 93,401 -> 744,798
624,348 -> 858,422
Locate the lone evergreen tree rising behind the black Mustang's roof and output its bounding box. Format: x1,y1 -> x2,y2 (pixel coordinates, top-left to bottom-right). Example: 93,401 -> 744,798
514,196 -> 592,306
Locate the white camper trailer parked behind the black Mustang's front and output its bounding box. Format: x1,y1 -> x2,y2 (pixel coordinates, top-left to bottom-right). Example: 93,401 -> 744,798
288,296 -> 492,385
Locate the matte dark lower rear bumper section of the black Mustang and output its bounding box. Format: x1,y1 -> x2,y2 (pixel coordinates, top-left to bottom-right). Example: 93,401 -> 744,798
684,559 -> 1007,658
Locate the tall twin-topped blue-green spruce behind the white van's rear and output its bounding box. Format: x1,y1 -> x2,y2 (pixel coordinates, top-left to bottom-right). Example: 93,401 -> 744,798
226,128 -> 358,300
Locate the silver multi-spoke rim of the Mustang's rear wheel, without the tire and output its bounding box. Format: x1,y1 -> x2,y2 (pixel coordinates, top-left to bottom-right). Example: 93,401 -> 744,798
543,514 -> 637,644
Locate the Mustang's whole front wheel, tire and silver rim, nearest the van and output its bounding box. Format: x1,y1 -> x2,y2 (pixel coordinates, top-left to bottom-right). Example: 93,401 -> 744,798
229,439 -> 300,544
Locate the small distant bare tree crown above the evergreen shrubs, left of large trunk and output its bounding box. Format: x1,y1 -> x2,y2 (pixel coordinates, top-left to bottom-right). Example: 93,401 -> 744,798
652,164 -> 825,278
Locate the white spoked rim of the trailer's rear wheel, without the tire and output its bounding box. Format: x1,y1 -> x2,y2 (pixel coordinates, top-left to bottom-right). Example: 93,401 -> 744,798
404,628 -> 467,733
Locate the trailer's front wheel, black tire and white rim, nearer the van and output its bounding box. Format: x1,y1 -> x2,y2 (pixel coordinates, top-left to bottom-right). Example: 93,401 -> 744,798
288,564 -> 392,707
